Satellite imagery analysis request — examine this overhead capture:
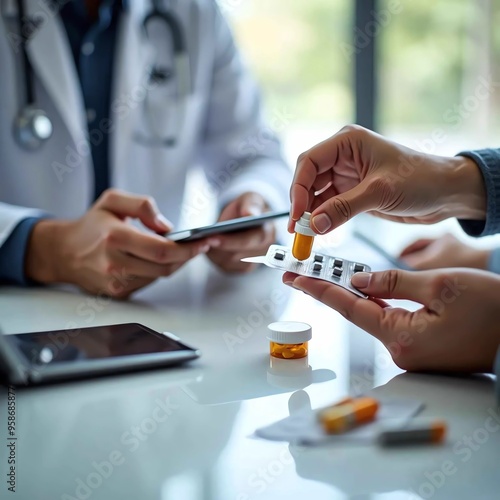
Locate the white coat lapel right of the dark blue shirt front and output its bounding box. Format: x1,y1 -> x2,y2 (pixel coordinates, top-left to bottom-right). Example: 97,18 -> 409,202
110,0 -> 153,186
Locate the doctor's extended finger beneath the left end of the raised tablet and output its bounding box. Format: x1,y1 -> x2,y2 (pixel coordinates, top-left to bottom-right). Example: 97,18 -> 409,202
107,225 -> 210,264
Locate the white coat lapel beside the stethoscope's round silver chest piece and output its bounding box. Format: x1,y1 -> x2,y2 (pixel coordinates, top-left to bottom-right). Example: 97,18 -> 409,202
26,0 -> 87,152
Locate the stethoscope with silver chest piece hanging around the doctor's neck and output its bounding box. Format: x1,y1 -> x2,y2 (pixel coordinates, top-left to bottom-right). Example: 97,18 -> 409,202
5,0 -> 191,151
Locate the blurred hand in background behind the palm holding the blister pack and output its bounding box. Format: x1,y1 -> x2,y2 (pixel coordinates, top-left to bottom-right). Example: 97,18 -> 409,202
399,234 -> 491,271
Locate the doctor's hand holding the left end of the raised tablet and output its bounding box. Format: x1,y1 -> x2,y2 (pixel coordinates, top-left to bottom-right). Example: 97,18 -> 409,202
26,190 -> 209,298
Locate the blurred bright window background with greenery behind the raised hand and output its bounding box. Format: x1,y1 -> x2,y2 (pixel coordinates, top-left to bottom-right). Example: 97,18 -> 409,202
219,0 -> 500,252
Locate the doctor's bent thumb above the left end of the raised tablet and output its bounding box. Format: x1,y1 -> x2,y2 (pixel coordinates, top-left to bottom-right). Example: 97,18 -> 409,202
95,189 -> 173,233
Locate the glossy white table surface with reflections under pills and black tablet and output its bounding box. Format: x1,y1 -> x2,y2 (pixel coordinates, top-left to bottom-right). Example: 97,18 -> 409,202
0,250 -> 500,500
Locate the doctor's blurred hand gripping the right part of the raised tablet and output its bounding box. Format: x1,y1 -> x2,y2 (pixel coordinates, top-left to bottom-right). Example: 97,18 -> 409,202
207,193 -> 276,273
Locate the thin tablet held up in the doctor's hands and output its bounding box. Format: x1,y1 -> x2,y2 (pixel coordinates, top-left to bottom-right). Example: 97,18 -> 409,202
165,210 -> 290,243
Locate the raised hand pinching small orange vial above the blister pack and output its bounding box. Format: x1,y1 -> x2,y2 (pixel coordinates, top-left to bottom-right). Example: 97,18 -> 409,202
289,125 -> 486,234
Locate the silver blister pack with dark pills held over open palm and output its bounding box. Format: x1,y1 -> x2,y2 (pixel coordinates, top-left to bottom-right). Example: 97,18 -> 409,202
241,245 -> 371,298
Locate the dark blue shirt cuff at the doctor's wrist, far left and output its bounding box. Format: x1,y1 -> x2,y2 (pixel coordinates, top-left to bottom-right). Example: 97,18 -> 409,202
0,217 -> 42,286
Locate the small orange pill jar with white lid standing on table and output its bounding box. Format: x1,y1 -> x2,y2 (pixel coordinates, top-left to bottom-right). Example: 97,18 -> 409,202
267,321 -> 312,359
